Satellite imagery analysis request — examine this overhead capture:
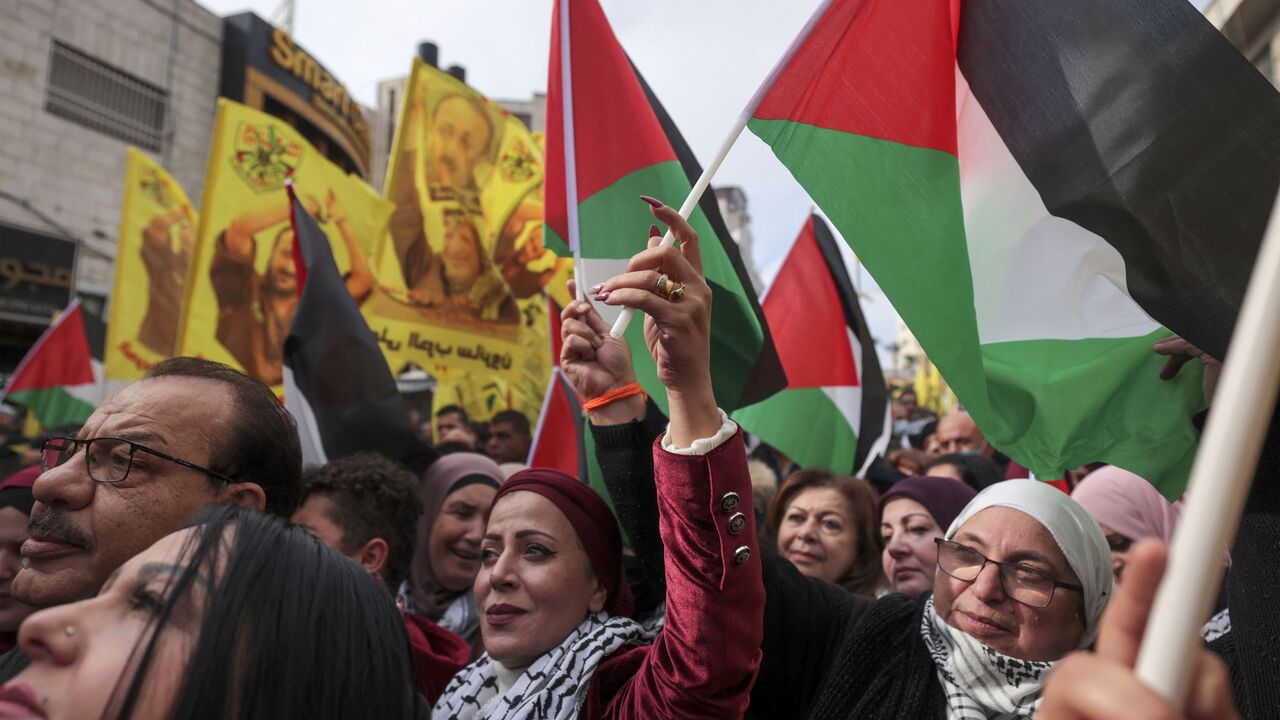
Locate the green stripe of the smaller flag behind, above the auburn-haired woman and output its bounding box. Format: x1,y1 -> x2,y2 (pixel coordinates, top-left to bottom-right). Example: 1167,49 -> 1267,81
733,388 -> 858,471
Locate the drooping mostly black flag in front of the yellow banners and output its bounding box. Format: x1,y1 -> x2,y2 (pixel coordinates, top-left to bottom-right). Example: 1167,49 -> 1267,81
284,184 -> 413,465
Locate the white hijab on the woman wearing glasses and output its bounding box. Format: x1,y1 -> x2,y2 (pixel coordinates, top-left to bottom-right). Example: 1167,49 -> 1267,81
946,480 -> 1115,640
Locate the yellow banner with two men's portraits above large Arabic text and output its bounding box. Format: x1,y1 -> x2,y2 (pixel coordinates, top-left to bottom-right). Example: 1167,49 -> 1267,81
364,60 -> 560,418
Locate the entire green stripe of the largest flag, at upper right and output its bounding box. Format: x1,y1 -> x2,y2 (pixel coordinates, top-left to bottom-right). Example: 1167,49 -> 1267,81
749,119 -> 1202,497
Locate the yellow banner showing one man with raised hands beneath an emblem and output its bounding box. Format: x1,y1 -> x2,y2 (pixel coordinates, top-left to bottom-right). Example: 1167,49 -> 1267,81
179,99 -> 392,392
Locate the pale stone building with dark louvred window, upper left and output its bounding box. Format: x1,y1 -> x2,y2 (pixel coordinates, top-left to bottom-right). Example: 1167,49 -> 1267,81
0,0 -> 223,361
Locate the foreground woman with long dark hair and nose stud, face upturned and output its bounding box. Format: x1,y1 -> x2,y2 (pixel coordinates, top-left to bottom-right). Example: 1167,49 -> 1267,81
0,505 -> 419,720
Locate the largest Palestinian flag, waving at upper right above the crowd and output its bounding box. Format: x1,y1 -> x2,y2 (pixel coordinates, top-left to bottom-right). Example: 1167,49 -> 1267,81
749,0 -> 1280,497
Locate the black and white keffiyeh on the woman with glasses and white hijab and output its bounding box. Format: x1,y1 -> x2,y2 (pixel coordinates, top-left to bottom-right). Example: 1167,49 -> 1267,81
920,597 -> 1053,720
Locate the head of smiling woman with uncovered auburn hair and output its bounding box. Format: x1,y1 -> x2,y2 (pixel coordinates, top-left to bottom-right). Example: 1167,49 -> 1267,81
764,469 -> 886,596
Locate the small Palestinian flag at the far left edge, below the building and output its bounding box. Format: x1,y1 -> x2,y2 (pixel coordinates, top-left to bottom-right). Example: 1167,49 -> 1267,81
0,299 -> 106,429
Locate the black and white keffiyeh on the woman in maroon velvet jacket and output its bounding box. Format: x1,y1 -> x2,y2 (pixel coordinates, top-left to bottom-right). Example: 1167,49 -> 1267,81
431,612 -> 654,720
